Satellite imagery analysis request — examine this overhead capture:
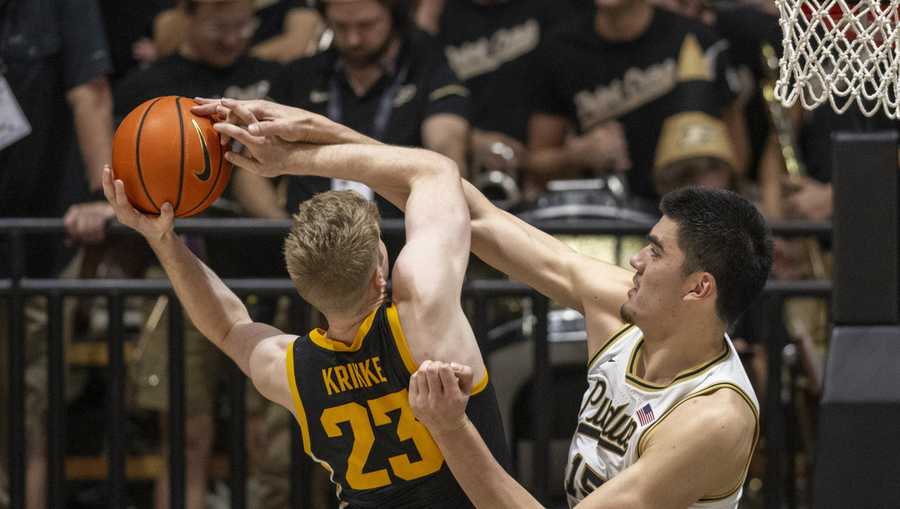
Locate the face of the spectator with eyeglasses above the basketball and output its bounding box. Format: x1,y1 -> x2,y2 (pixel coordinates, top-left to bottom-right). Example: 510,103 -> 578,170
187,0 -> 259,67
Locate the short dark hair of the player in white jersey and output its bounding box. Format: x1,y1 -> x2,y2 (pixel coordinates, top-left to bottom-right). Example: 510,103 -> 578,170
659,187 -> 772,324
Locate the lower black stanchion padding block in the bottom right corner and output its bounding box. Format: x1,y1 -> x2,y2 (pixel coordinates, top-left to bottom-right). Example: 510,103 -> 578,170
813,325 -> 900,509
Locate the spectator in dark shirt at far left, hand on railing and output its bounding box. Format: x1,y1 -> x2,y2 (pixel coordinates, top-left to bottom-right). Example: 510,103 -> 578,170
0,0 -> 112,507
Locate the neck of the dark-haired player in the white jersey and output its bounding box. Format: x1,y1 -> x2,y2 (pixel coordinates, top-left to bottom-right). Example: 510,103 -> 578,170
635,319 -> 725,385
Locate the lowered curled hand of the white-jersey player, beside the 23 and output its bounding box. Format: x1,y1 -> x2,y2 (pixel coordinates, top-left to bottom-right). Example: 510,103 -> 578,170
409,361 -> 472,434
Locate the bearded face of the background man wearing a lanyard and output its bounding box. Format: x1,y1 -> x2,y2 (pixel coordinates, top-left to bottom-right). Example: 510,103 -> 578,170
325,0 -> 393,67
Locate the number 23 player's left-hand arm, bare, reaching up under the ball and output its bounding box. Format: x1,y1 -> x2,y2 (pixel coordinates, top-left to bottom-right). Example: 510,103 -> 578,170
103,167 -> 293,409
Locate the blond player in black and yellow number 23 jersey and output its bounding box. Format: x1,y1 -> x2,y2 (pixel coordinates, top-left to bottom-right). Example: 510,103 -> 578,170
103,131 -> 506,508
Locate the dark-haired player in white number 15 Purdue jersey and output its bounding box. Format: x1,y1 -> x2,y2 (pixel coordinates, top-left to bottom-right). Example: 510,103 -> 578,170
195,96 -> 772,509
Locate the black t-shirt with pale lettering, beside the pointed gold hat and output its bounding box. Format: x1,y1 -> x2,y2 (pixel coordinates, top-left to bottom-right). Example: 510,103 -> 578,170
534,8 -> 734,200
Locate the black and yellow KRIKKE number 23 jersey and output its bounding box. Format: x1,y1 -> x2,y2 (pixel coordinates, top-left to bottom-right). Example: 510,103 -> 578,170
287,303 -> 508,509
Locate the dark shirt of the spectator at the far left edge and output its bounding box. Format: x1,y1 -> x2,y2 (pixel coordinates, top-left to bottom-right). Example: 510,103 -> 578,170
0,0 -> 112,276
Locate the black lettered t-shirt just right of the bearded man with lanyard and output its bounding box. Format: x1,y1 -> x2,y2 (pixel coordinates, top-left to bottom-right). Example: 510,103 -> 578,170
438,0 -> 572,142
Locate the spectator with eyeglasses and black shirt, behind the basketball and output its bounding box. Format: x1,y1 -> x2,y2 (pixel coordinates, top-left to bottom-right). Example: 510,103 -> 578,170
114,0 -> 286,509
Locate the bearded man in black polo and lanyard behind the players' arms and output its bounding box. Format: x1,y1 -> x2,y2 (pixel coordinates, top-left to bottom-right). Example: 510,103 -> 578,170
273,0 -> 468,217
